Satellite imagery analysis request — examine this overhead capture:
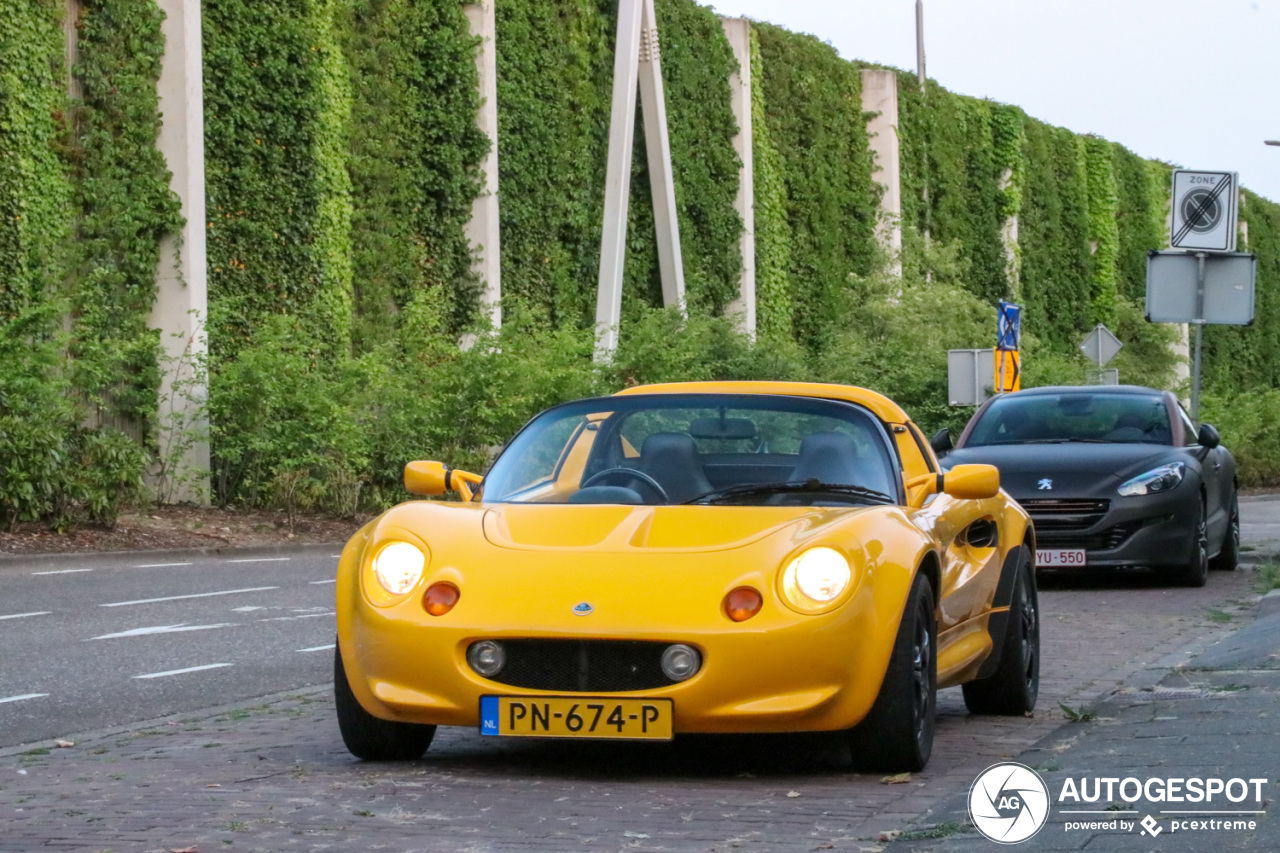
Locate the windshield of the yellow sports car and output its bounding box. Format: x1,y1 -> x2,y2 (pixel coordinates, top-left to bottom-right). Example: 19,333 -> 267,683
483,394 -> 901,506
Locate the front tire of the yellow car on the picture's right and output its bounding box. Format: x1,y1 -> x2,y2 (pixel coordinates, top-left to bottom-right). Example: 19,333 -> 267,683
845,573 -> 938,772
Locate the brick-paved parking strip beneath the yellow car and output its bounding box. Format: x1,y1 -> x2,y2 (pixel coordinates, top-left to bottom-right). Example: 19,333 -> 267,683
0,563 -> 1253,853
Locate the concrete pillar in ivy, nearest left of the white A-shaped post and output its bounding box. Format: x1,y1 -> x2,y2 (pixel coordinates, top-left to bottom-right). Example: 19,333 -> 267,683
465,0 -> 502,329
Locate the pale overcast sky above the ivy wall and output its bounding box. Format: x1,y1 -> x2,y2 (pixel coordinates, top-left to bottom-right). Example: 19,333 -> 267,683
703,0 -> 1280,201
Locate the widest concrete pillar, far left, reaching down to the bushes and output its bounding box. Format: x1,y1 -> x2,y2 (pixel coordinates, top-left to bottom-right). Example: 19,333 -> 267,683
151,0 -> 209,503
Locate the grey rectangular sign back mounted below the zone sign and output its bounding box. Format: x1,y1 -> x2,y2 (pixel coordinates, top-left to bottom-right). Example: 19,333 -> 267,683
1147,251 -> 1258,325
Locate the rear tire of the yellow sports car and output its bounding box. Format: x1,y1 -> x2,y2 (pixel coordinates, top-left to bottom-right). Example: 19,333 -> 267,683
961,547 -> 1041,717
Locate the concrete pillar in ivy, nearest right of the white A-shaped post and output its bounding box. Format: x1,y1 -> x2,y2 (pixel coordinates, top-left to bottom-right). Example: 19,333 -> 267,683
721,18 -> 755,341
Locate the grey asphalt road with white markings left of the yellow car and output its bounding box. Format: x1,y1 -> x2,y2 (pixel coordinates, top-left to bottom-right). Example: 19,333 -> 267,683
0,547 -> 339,747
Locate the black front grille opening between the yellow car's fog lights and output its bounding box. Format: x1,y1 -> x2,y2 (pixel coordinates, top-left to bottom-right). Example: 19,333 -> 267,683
490,639 -> 675,693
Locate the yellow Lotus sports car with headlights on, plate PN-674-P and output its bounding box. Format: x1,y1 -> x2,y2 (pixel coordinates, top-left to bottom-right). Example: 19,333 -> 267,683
334,382 -> 1039,771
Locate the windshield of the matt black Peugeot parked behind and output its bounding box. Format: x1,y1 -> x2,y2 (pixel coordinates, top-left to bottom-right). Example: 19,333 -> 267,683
964,392 -> 1172,447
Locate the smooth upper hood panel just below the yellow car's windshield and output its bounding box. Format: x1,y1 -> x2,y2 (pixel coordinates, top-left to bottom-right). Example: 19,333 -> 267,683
483,503 -> 851,553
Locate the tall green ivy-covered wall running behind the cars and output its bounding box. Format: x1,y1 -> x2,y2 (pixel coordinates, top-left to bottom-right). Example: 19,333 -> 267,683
0,0 -> 1280,521
